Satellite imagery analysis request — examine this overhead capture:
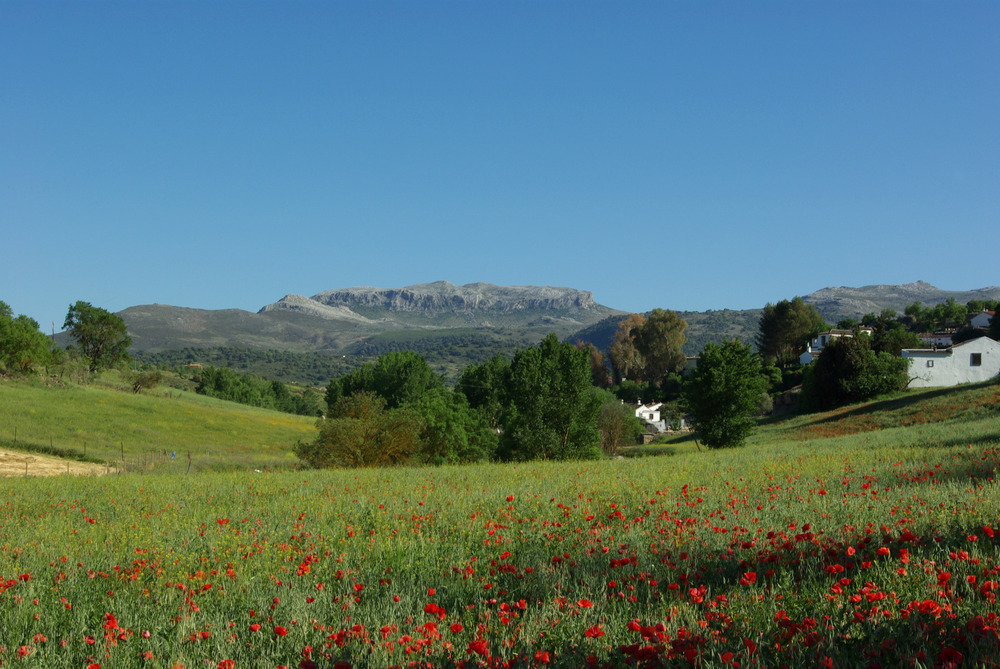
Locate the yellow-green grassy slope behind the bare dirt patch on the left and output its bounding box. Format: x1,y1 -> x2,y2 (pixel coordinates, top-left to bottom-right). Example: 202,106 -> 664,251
0,370 -> 315,471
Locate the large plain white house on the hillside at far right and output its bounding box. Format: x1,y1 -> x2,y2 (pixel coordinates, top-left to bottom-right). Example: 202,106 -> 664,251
902,337 -> 1000,388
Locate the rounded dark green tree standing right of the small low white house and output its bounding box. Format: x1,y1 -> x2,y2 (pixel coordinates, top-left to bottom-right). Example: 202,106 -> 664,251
684,340 -> 768,448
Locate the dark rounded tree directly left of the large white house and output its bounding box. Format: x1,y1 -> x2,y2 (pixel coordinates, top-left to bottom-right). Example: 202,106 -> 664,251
800,336 -> 910,410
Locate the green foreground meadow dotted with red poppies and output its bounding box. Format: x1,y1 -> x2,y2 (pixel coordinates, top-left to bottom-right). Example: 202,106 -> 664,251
0,378 -> 1000,669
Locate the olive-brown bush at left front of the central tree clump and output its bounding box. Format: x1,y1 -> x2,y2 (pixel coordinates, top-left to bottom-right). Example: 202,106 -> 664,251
294,390 -> 421,468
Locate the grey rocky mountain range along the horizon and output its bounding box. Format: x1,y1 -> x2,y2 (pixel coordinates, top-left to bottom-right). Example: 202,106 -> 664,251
119,281 -> 1000,384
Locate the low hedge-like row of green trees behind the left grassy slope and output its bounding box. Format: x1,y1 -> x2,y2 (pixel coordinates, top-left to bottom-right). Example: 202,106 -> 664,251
195,367 -> 322,416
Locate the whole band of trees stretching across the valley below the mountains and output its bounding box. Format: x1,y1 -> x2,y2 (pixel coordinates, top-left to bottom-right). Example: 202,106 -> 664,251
7,297 -> 1000,467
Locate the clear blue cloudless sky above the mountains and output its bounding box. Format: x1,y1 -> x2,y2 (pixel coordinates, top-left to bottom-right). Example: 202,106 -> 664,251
0,0 -> 1000,331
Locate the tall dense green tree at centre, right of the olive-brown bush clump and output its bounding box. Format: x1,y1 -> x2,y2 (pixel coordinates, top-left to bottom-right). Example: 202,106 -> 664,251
498,334 -> 600,460
